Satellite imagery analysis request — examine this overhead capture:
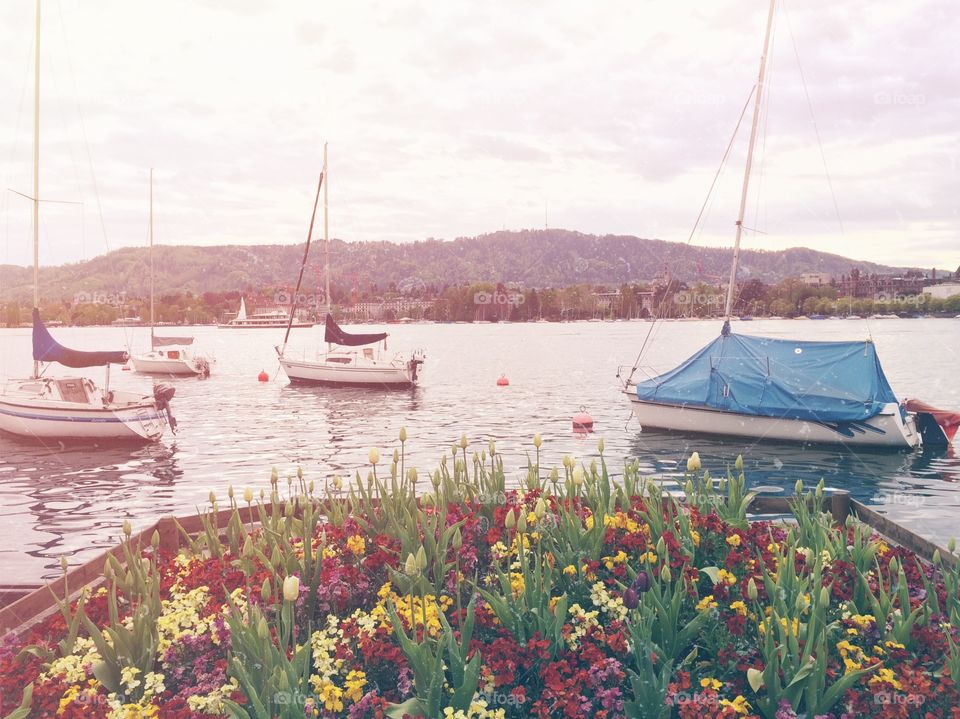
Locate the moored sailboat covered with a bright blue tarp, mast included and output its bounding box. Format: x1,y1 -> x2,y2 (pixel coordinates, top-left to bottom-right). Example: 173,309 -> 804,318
622,0 -> 947,449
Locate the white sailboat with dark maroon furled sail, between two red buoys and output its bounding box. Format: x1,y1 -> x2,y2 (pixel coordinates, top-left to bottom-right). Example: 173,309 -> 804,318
276,143 -> 425,389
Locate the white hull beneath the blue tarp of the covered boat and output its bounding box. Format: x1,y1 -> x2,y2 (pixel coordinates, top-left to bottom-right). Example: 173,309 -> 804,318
624,388 -> 920,449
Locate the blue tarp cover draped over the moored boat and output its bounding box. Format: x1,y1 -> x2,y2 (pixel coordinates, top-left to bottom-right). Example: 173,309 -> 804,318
637,334 -> 897,422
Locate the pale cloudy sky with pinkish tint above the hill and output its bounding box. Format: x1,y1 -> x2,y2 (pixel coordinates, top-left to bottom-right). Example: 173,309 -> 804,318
0,0 -> 960,269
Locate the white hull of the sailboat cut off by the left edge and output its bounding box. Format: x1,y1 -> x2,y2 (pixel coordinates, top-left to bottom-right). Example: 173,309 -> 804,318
0,380 -> 166,442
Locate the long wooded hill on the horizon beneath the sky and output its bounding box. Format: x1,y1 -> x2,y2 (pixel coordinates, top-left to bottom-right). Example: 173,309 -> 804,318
0,230 -> 932,301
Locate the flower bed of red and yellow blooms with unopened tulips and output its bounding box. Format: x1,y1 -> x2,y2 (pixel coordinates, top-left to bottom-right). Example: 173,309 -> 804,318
0,434 -> 960,719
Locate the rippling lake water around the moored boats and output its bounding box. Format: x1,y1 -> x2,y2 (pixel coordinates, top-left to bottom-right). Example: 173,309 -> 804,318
0,319 -> 960,583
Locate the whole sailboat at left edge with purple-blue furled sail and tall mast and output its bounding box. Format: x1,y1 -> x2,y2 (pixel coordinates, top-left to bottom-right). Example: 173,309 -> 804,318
0,0 -> 176,441
